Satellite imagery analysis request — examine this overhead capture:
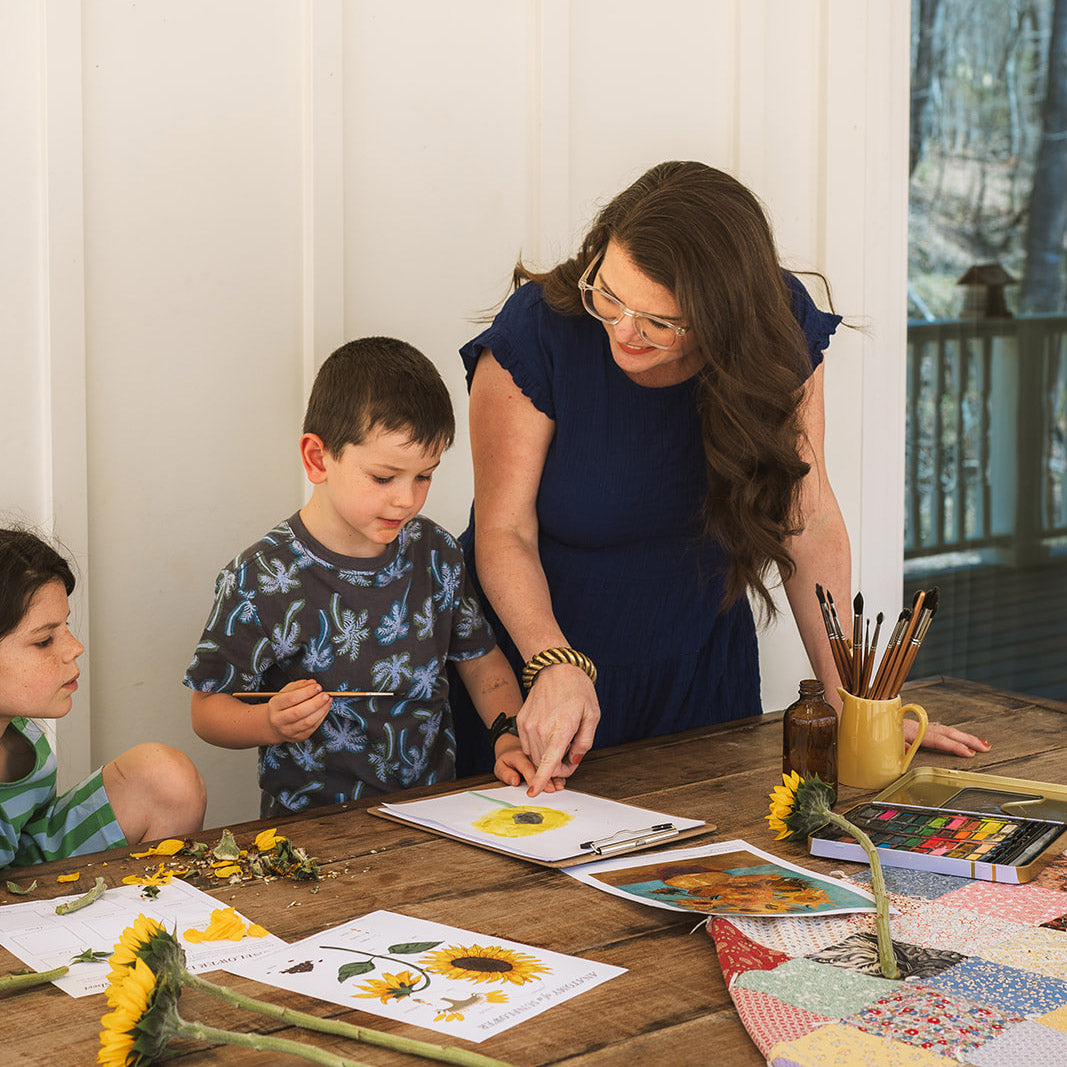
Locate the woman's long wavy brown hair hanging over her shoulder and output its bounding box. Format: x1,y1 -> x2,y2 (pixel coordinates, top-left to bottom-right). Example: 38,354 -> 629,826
514,162 -> 811,618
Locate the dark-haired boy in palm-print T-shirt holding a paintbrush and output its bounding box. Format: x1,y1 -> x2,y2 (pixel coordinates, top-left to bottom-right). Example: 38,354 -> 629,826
185,337 -> 542,818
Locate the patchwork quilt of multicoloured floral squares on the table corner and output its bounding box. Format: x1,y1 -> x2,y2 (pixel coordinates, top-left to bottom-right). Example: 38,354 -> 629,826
707,854 -> 1067,1067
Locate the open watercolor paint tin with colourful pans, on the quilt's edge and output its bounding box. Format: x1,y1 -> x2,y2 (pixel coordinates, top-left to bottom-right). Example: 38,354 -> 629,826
808,767 -> 1067,882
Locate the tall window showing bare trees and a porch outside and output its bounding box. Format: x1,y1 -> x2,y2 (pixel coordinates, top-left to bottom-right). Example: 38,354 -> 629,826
904,0 -> 1067,700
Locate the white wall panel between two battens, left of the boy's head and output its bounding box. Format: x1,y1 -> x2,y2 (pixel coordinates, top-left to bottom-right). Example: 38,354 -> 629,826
83,0 -> 307,821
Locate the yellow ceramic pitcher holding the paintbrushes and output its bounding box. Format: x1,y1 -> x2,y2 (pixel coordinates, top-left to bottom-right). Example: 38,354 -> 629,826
838,688 -> 928,790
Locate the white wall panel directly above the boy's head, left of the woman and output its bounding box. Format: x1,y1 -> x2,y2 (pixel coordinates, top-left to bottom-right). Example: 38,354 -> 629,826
345,0 -> 531,531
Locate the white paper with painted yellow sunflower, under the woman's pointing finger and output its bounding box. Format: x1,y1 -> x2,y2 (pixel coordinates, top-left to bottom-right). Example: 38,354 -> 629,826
380,785 -> 706,863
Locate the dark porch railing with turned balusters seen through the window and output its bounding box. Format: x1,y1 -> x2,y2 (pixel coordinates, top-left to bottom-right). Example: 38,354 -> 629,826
905,315 -> 1067,564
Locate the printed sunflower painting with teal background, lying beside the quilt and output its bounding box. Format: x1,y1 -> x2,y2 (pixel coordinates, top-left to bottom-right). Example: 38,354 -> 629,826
564,841 -> 875,915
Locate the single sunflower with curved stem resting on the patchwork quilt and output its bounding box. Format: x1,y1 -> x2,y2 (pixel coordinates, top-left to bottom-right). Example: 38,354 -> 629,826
764,770 -> 901,978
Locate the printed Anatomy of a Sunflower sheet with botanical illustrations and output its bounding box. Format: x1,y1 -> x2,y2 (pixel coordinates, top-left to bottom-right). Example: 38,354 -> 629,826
225,911 -> 625,1041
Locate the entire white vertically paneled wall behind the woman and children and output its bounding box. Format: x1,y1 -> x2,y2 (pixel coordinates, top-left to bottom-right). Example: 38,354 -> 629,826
0,0 -> 908,825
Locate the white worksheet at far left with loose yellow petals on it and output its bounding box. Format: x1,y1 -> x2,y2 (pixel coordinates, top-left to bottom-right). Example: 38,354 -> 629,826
0,878 -> 285,997
